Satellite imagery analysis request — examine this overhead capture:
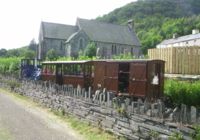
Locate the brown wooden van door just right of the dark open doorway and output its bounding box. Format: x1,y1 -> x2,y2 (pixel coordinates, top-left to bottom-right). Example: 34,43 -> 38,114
129,62 -> 147,97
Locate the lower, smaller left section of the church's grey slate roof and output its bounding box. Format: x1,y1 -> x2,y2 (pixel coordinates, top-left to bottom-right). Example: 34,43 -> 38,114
42,22 -> 78,40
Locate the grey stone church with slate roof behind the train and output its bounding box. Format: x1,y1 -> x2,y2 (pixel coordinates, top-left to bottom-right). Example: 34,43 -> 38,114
38,18 -> 141,59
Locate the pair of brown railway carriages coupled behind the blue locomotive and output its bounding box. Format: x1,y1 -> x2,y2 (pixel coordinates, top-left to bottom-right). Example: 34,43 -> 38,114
41,59 -> 165,100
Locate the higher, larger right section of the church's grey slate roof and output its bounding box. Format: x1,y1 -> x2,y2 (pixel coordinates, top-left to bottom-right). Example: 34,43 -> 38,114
77,18 -> 141,46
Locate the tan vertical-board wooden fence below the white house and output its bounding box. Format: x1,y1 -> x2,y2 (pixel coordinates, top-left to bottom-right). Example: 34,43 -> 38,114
148,47 -> 200,75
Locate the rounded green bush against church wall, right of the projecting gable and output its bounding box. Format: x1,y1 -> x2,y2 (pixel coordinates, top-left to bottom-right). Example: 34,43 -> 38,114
85,42 -> 97,58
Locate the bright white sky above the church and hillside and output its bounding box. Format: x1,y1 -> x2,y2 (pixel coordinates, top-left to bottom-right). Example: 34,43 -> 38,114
0,0 -> 135,50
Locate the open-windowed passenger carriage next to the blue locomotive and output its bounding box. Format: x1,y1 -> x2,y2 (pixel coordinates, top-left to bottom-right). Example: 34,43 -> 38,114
42,61 -> 94,88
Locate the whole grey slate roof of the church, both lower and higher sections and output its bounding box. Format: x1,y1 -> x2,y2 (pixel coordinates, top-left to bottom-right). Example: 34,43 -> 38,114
41,18 -> 141,46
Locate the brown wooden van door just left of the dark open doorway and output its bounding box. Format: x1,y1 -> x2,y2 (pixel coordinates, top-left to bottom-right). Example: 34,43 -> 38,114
104,62 -> 119,93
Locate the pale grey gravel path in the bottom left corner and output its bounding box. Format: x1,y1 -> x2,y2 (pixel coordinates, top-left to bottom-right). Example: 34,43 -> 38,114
0,93 -> 82,140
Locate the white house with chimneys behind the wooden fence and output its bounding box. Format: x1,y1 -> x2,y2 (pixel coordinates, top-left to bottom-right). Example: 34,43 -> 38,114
156,29 -> 200,48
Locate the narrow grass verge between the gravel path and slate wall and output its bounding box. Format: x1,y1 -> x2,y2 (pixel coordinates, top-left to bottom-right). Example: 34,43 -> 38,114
0,89 -> 119,140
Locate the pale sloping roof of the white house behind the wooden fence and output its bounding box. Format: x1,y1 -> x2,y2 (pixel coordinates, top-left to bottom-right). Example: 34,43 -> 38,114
159,33 -> 200,45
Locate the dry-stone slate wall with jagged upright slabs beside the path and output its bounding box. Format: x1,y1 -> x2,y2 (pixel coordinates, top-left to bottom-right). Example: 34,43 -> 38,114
0,81 -> 200,140
